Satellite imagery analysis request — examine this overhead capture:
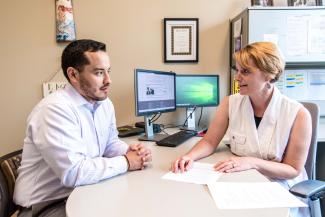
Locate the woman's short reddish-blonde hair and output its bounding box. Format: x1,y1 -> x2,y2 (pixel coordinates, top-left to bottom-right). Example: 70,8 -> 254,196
234,42 -> 285,82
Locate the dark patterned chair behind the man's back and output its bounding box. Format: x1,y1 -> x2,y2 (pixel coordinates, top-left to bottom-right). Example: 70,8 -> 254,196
0,150 -> 22,217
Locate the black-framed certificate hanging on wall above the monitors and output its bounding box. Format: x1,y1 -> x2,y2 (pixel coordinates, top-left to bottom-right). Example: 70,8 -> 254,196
164,18 -> 199,62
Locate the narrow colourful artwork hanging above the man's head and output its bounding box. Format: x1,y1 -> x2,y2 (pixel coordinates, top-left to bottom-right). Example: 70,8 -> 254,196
55,0 -> 76,42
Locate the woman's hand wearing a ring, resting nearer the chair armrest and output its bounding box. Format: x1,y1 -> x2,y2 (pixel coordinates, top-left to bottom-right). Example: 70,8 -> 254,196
214,157 -> 256,173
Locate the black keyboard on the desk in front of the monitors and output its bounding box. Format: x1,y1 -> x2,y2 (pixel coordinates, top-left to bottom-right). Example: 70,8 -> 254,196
156,130 -> 196,147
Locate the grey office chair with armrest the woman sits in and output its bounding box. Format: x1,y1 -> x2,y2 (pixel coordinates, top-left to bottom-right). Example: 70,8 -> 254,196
289,102 -> 325,217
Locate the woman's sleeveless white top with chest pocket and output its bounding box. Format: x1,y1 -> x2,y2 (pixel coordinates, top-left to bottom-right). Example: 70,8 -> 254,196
228,87 -> 308,188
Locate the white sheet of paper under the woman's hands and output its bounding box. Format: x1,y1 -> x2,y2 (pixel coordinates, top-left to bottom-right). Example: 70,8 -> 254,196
161,162 -> 221,185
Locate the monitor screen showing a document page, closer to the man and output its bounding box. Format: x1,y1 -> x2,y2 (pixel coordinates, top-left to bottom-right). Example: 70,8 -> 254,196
134,69 -> 176,116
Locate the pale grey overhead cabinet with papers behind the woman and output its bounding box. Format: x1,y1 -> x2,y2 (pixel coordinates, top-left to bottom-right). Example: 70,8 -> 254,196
230,6 -> 325,116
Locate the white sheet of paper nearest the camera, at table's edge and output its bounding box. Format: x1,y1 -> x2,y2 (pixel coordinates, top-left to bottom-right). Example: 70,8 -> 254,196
208,182 -> 307,209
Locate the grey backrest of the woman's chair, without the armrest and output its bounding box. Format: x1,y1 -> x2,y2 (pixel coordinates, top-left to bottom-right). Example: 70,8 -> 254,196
302,102 -> 319,179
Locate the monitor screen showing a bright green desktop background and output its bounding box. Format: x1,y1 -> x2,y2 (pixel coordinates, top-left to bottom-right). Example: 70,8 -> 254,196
176,75 -> 219,107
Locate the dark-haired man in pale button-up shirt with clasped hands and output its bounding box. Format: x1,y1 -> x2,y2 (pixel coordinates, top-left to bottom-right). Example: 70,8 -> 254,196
14,40 -> 151,216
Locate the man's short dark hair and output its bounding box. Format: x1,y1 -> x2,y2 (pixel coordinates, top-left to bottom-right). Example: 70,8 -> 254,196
61,39 -> 106,82
